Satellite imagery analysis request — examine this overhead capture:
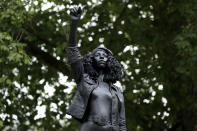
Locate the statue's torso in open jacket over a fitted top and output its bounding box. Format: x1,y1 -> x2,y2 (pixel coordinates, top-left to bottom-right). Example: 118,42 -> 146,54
67,74 -> 124,131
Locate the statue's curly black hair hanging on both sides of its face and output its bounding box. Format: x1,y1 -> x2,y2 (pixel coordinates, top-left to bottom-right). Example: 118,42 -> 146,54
83,53 -> 122,83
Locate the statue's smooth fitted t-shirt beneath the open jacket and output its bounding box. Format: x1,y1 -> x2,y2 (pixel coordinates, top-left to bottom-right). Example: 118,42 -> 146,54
88,76 -> 119,124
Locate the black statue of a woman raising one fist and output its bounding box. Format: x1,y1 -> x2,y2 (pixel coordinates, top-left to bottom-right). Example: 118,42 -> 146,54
67,7 -> 126,131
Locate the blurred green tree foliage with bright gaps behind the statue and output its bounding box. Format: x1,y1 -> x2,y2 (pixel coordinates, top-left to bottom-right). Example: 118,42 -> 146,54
0,0 -> 197,131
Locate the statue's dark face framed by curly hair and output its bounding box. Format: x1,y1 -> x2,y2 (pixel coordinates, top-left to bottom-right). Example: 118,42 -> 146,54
94,50 -> 108,68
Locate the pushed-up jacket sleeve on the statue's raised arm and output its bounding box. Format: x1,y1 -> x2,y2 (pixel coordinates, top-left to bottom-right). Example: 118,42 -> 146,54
68,46 -> 84,84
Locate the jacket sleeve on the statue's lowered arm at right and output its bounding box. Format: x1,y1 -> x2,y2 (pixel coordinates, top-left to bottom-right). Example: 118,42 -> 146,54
119,93 -> 127,131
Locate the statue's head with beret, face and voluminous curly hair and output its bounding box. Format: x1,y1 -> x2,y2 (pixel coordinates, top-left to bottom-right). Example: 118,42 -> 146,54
83,47 -> 122,83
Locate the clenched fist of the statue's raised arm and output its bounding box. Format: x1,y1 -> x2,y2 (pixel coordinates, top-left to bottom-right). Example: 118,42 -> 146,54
70,7 -> 82,20
